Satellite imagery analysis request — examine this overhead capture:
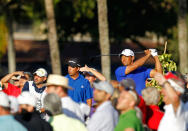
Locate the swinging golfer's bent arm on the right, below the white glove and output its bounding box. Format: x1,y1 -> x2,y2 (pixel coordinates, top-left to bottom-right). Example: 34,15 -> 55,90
150,56 -> 163,77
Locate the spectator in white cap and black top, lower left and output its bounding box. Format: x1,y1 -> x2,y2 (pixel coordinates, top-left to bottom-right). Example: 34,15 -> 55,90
15,91 -> 52,131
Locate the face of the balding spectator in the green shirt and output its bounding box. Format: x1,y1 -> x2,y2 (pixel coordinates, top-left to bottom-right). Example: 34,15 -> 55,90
116,90 -> 132,111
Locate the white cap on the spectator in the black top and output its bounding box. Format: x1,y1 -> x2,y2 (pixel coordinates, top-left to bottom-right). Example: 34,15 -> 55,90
18,91 -> 36,107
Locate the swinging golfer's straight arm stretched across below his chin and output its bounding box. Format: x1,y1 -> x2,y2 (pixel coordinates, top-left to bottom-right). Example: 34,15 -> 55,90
125,54 -> 150,74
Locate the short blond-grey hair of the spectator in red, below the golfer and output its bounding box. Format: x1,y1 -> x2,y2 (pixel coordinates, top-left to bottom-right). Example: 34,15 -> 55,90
142,87 -> 160,105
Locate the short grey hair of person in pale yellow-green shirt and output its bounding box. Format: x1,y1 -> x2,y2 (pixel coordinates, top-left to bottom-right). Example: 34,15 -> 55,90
44,93 -> 62,116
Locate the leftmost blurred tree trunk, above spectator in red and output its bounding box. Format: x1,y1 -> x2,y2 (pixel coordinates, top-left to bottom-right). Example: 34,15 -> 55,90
6,10 -> 16,73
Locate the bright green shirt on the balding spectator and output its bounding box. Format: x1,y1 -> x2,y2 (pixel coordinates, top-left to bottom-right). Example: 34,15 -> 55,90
114,110 -> 144,131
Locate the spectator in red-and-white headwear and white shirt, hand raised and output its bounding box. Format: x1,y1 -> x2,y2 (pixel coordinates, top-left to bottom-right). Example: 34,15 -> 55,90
155,72 -> 188,131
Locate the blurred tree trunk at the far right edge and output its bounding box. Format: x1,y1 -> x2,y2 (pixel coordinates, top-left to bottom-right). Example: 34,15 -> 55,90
178,0 -> 188,73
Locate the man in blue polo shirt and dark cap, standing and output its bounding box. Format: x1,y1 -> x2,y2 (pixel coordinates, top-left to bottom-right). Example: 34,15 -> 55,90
66,58 -> 93,107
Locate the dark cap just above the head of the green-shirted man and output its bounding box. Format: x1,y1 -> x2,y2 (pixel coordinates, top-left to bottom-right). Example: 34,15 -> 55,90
120,78 -> 136,90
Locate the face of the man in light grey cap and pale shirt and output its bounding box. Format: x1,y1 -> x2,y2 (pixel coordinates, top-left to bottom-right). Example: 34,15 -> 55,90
93,89 -> 107,103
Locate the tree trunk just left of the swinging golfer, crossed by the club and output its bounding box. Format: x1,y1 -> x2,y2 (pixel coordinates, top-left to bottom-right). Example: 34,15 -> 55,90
97,0 -> 111,80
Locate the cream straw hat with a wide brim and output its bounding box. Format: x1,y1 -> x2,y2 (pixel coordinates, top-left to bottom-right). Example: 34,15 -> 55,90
45,74 -> 72,89
